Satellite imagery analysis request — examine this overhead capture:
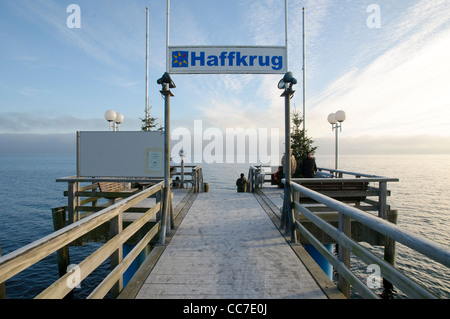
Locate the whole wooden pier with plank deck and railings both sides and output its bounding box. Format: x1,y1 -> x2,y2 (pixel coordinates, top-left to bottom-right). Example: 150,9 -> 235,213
0,166 -> 450,299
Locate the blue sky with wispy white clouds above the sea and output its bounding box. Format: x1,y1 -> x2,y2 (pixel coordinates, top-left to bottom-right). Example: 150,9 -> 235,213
0,0 -> 450,158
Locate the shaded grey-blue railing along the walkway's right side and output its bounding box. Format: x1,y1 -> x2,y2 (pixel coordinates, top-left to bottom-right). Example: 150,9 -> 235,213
283,180 -> 450,298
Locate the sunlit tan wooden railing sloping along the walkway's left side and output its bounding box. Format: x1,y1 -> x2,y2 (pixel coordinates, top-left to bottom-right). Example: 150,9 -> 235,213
0,182 -> 164,299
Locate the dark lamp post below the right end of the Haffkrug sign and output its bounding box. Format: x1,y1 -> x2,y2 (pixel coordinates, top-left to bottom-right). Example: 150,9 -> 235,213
278,72 -> 297,243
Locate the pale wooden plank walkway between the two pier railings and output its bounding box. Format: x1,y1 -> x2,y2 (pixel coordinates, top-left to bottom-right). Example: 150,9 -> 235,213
136,191 -> 326,299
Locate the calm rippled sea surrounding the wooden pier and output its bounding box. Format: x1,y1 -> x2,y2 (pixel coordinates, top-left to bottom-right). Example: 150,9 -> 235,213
0,155 -> 450,298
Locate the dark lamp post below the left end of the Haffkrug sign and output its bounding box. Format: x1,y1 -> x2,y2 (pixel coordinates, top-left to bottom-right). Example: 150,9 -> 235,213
156,72 -> 176,245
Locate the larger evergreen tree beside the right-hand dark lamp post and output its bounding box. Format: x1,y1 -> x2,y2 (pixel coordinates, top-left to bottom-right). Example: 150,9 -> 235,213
291,110 -> 317,177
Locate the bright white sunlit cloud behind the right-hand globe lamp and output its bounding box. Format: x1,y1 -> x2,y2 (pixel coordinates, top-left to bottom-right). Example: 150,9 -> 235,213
307,2 -> 450,137
